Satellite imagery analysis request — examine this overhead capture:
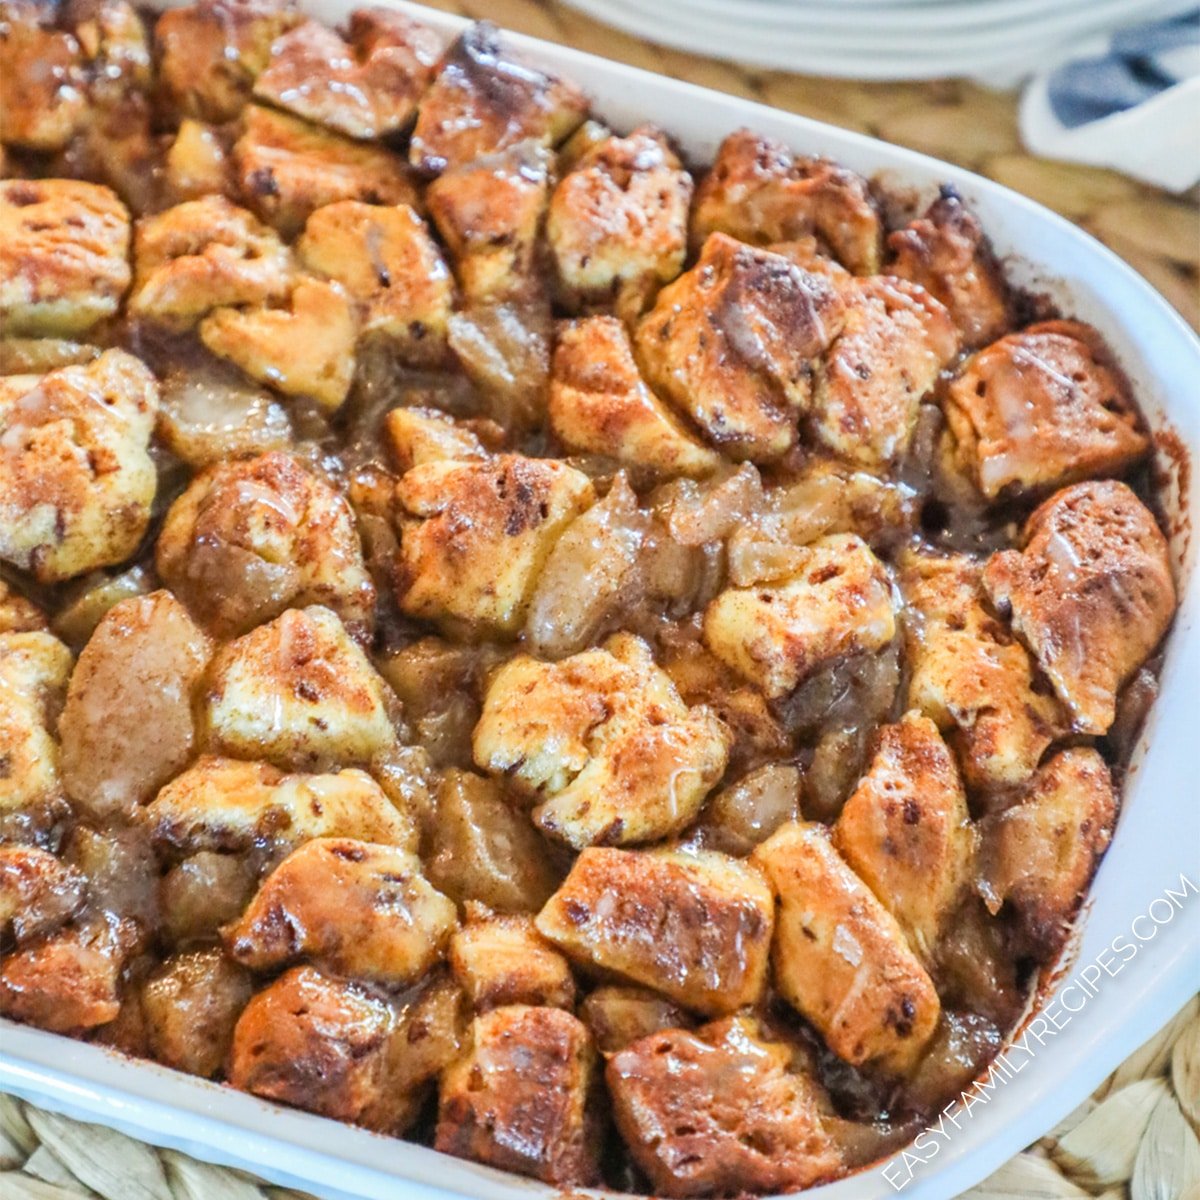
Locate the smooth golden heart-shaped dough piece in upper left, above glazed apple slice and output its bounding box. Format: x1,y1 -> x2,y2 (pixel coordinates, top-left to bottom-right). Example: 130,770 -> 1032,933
200,277 -> 358,413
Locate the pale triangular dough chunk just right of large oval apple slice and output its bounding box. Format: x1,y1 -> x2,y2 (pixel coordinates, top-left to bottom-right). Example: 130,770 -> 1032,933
206,606 -> 396,769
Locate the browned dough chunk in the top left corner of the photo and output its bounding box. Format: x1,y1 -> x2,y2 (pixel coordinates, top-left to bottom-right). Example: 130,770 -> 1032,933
0,0 -> 88,150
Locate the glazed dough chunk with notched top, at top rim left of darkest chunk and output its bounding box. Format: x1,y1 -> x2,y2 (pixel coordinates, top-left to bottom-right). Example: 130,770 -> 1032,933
254,8 -> 442,139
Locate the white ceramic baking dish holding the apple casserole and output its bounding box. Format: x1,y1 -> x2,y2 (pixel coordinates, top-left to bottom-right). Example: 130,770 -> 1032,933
0,0 -> 1200,1200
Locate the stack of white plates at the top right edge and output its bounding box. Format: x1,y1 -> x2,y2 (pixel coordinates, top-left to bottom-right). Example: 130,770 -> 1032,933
566,0 -> 1196,79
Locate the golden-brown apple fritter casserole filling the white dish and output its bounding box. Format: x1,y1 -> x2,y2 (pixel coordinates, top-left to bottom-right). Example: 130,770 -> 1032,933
0,0 -> 1176,1196
